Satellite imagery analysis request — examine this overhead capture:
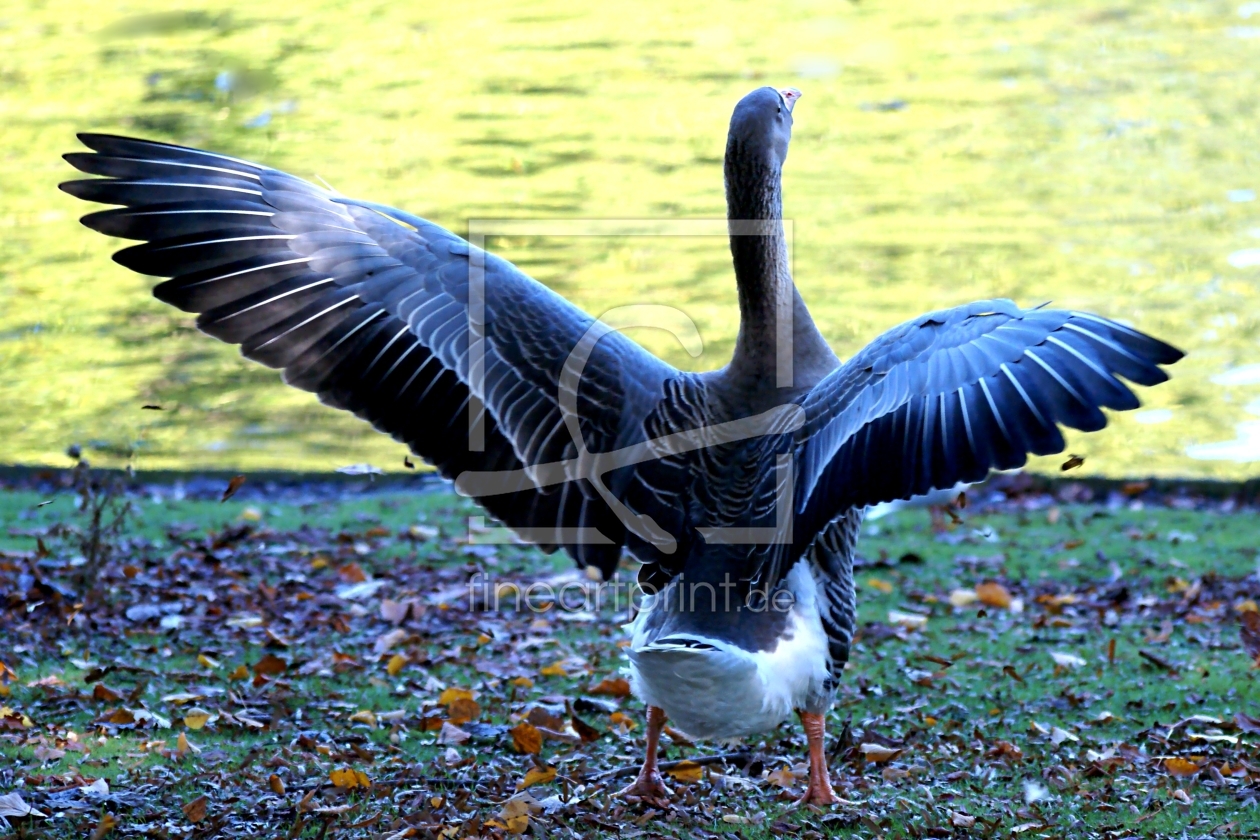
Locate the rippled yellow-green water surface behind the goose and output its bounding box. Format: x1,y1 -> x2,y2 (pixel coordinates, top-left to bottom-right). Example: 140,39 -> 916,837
0,0 -> 1260,479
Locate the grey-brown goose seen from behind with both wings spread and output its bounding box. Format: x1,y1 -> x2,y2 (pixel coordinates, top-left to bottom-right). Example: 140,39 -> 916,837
60,87 -> 1182,806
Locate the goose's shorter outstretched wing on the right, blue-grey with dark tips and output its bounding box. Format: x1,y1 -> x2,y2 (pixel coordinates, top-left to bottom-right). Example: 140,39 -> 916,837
798,300 -> 1182,534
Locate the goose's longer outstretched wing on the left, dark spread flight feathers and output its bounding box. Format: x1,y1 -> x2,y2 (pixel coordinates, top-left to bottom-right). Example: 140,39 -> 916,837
62,135 -> 675,574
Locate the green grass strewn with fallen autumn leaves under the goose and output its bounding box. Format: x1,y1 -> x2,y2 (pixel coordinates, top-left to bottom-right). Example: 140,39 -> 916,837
0,476 -> 1260,840
